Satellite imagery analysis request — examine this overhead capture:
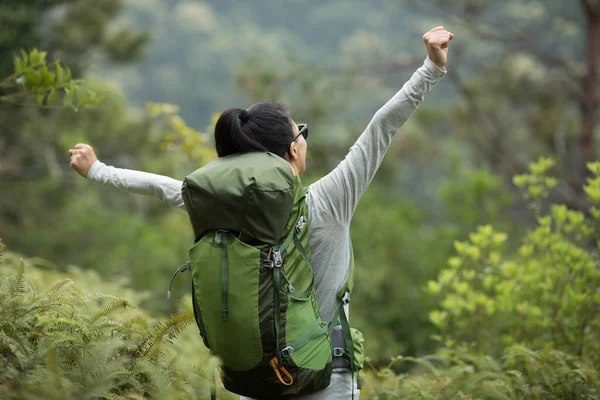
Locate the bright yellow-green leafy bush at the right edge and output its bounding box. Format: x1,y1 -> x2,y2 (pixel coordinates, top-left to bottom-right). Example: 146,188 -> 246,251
428,159 -> 600,366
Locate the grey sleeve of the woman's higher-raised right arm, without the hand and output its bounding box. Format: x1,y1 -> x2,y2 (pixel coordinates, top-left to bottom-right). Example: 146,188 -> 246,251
308,58 -> 446,226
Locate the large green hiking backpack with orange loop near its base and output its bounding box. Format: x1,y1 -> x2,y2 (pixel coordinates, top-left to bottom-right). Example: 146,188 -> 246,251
176,153 -> 362,399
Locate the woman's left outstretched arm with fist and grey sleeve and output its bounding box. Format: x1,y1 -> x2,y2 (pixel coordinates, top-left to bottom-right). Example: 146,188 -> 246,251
69,143 -> 185,209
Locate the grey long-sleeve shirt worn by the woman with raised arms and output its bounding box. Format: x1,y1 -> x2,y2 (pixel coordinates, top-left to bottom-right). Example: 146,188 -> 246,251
88,59 -> 446,400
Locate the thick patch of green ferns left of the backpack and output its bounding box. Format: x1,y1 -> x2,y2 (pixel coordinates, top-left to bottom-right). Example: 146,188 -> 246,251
0,242 -> 234,399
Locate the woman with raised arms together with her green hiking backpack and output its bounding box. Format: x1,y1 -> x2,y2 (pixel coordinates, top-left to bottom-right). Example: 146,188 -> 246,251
69,27 -> 453,399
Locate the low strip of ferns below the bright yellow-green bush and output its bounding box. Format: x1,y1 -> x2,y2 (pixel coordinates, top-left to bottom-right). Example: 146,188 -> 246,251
361,346 -> 600,400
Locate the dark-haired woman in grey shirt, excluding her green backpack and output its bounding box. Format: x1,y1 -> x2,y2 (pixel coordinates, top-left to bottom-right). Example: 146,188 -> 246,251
69,26 -> 454,399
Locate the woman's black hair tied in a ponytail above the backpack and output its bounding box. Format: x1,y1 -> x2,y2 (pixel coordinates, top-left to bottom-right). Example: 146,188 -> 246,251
215,103 -> 294,157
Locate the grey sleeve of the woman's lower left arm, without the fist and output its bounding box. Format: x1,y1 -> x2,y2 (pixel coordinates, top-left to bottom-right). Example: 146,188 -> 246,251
87,161 -> 185,209
